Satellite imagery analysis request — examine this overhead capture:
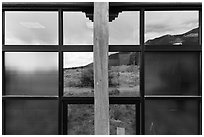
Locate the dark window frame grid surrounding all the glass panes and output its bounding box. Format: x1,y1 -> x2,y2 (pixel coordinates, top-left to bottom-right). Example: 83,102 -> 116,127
2,2 -> 202,135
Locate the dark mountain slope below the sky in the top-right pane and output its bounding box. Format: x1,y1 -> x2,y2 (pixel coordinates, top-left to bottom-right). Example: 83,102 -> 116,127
145,28 -> 199,45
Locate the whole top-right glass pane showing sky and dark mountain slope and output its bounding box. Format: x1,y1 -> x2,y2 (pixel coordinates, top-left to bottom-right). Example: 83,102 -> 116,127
145,11 -> 199,45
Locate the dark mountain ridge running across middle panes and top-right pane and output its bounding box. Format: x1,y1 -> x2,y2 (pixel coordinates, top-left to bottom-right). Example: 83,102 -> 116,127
64,28 -> 199,69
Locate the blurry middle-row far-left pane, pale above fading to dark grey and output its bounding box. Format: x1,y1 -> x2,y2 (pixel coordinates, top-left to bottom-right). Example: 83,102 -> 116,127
5,52 -> 58,95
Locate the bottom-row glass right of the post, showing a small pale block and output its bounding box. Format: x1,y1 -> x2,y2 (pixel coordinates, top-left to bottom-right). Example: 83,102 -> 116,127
110,104 -> 136,135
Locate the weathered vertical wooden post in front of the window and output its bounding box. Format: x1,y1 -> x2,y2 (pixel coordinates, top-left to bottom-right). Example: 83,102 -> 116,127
93,2 -> 109,135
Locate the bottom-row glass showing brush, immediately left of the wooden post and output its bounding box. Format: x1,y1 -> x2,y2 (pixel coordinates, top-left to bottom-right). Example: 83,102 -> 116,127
67,104 -> 94,135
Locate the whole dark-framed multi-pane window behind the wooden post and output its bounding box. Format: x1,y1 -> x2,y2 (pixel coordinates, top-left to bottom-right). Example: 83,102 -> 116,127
2,2 -> 202,135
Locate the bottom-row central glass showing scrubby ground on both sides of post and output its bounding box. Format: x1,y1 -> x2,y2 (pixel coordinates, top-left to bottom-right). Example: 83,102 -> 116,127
67,104 -> 136,135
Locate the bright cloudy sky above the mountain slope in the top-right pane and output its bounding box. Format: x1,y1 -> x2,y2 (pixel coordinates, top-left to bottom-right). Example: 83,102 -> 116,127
145,11 -> 198,41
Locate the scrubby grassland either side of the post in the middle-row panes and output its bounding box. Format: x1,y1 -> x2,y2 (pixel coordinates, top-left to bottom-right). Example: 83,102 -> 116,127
64,65 -> 139,96
